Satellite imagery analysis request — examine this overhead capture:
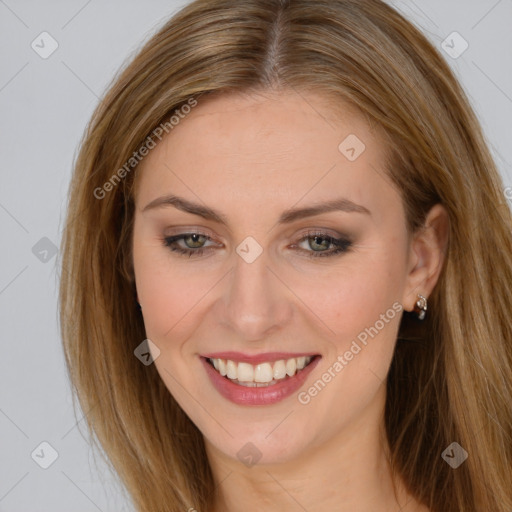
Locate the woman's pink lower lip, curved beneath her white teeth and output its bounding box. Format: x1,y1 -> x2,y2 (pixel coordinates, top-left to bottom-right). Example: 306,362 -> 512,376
201,357 -> 320,405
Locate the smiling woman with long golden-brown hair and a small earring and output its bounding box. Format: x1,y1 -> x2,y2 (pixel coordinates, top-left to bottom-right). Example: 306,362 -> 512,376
60,0 -> 512,512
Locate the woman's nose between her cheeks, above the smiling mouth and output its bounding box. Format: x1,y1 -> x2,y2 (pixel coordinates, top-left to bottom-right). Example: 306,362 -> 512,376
212,251 -> 293,341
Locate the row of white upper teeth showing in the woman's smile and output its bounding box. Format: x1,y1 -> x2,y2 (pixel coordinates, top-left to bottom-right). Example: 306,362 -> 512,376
210,356 -> 313,383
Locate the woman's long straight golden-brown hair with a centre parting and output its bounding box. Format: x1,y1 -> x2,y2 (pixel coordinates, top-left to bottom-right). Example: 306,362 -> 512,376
60,0 -> 512,512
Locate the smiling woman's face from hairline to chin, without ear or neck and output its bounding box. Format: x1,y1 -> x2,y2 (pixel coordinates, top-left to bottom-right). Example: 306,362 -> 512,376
133,92 -> 421,463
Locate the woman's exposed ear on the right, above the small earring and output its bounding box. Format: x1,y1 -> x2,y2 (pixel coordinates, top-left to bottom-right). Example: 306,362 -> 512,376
402,204 -> 450,311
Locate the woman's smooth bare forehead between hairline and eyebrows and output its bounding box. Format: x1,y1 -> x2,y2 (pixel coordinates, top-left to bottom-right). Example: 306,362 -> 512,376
135,91 -> 396,219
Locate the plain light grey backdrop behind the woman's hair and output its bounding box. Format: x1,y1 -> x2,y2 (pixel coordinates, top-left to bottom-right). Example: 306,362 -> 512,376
0,0 -> 512,512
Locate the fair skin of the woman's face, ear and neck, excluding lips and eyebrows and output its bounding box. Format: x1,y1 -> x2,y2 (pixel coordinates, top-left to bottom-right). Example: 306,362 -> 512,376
133,91 -> 448,512
